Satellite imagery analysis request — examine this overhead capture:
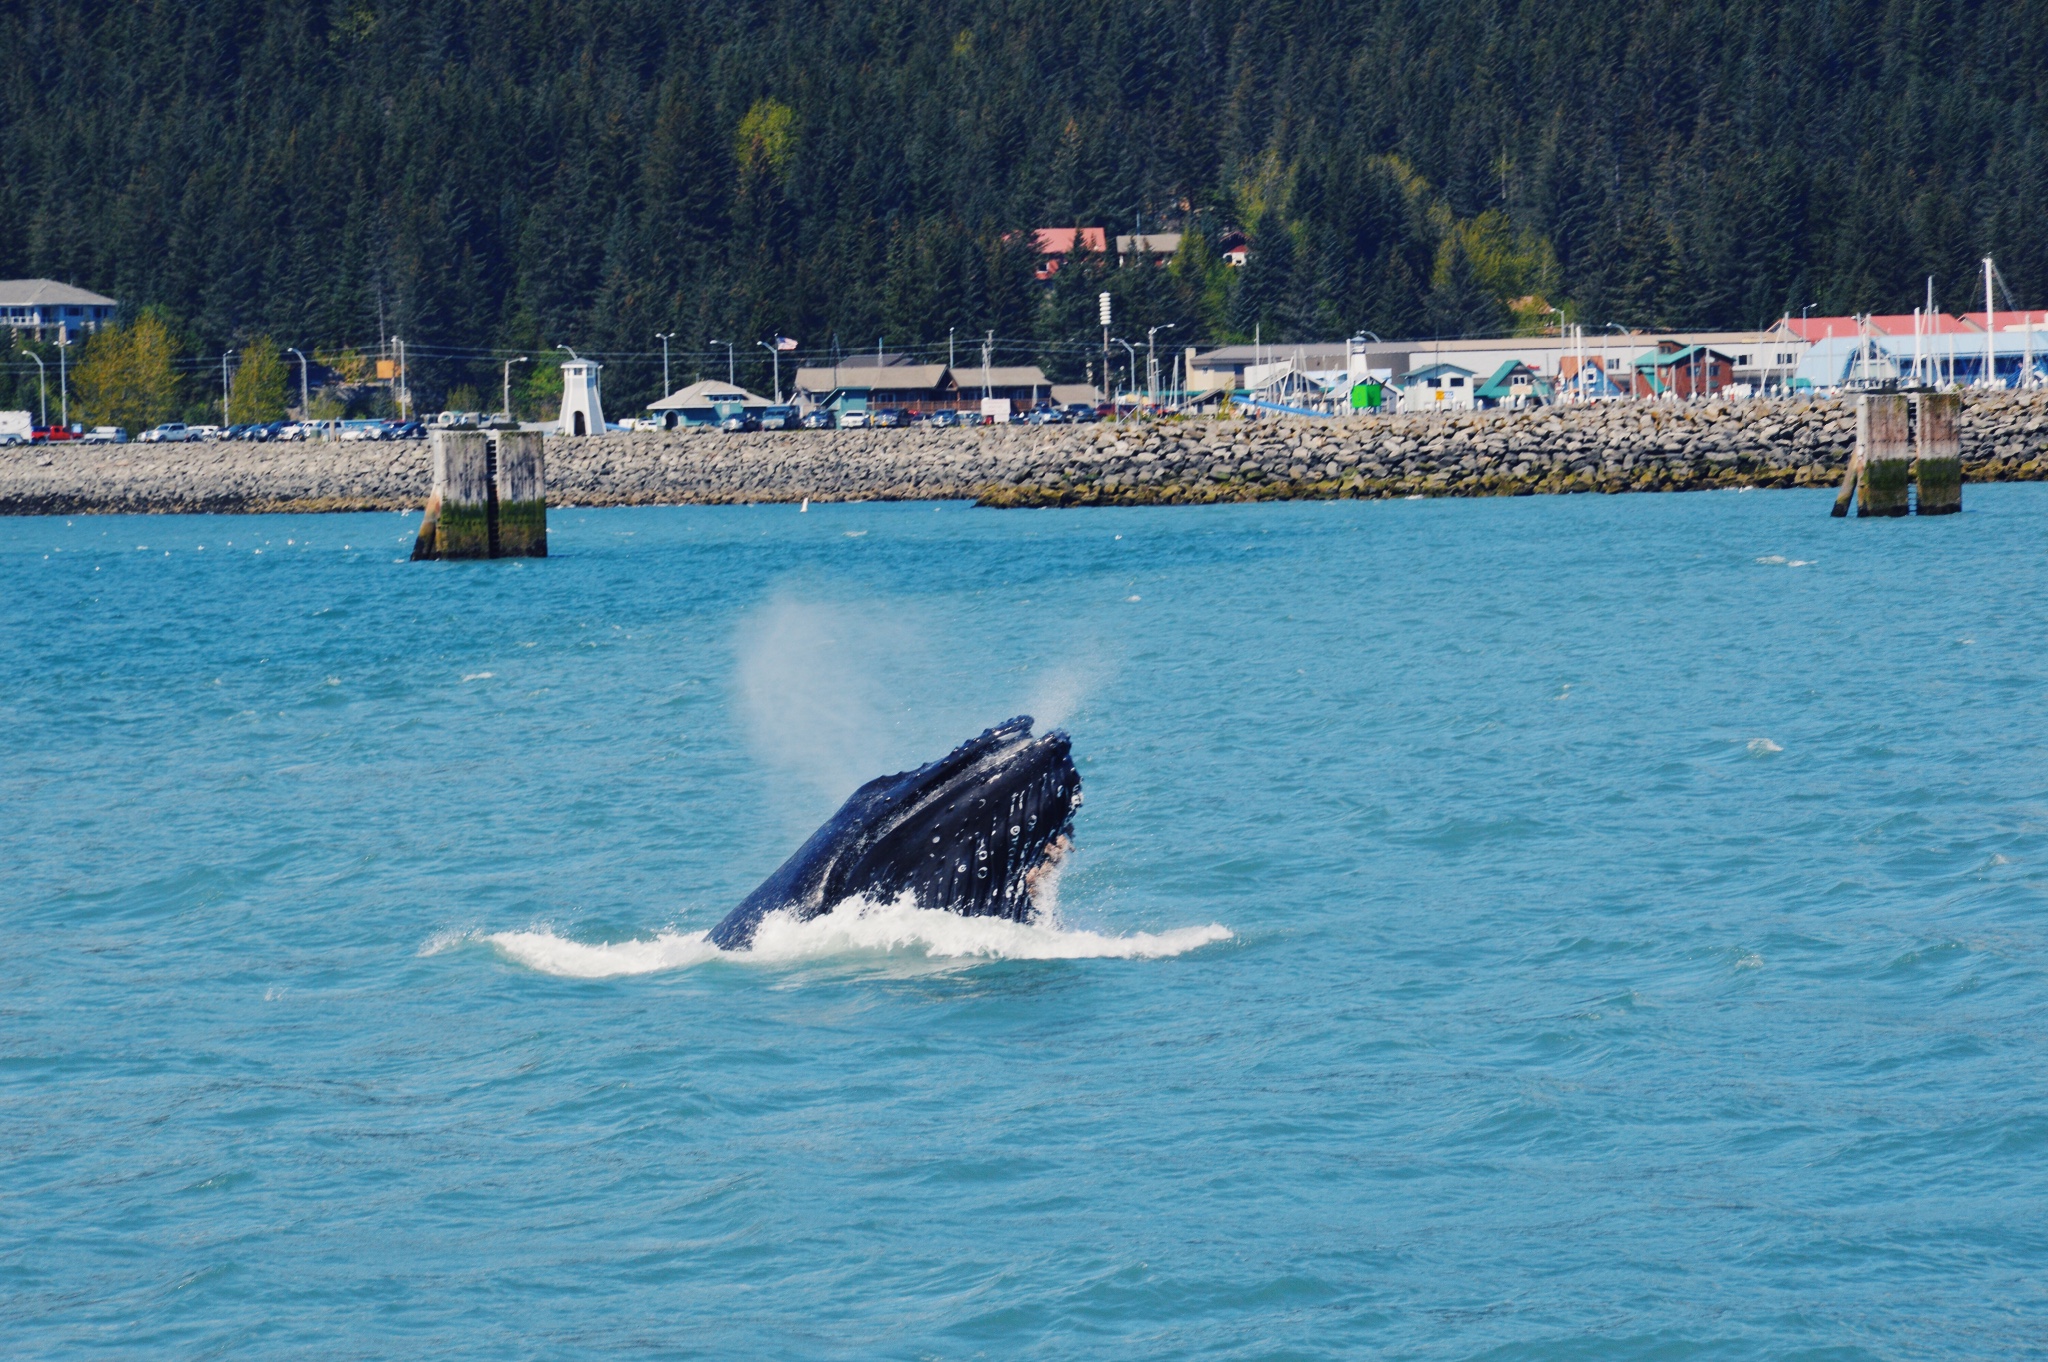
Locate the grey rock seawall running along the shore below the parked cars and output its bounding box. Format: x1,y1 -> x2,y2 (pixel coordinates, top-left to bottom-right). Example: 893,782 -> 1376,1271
12,391 -> 2048,514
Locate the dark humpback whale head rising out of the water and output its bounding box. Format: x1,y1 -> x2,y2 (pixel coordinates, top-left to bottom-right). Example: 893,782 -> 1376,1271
711,715 -> 1081,950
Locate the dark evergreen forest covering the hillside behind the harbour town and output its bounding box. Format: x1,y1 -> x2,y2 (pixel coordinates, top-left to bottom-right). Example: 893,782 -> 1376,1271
0,0 -> 2048,422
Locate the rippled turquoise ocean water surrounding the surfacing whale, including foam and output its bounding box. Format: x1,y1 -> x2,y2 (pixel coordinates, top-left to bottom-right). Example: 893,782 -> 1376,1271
0,485 -> 2048,1360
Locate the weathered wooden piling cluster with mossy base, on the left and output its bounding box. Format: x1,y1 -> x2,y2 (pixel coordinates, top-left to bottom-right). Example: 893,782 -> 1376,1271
412,430 -> 547,561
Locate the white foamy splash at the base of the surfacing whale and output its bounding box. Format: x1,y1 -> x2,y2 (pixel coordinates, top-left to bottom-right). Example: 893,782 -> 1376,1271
466,899 -> 1235,979
